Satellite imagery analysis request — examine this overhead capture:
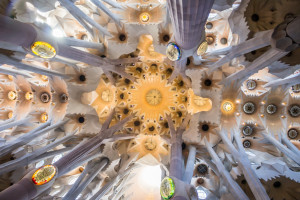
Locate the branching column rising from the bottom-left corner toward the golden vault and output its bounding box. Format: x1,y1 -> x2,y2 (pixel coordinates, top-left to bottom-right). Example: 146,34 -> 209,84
0,111 -> 134,200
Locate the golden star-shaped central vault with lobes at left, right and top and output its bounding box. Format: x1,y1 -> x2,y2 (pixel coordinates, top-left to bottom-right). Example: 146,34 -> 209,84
82,36 -> 212,135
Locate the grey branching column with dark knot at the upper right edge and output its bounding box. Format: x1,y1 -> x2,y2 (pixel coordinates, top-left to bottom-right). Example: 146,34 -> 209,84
209,17 -> 300,87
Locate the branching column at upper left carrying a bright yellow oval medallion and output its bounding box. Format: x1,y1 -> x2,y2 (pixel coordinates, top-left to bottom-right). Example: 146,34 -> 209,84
0,15 -> 138,81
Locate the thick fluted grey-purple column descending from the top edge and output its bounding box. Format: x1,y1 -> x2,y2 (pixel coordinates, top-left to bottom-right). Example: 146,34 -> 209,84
167,0 -> 214,81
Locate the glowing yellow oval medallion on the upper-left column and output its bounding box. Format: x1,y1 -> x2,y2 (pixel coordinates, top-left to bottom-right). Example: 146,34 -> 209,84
31,41 -> 56,58
